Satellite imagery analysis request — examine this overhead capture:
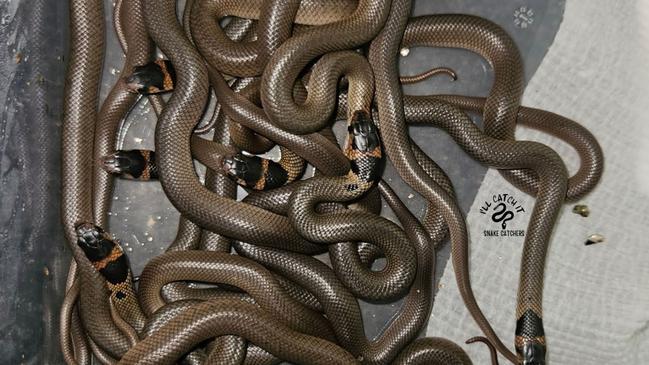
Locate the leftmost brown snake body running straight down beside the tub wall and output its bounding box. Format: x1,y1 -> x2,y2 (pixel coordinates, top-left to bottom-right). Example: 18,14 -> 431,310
62,1 -> 139,359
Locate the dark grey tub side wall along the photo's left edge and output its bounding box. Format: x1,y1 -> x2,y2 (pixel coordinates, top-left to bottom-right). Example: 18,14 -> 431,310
0,0 -> 69,364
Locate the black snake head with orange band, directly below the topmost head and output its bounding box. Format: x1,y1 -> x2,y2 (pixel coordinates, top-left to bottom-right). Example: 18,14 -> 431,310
99,150 -> 157,180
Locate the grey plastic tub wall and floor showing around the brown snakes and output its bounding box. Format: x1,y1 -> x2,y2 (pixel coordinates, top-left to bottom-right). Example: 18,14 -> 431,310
0,0 -> 565,364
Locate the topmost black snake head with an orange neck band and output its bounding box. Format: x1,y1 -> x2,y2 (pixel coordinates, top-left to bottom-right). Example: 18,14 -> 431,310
124,60 -> 176,95
